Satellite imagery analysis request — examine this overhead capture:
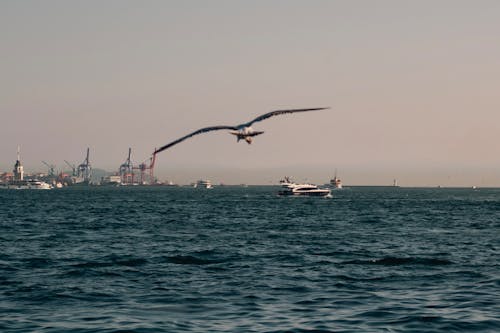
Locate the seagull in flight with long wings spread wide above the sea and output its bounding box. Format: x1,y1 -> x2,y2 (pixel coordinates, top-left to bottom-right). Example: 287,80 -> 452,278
154,107 -> 329,154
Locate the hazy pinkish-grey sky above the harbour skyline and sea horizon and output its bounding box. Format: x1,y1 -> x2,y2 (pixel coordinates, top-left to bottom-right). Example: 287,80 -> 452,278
0,0 -> 500,186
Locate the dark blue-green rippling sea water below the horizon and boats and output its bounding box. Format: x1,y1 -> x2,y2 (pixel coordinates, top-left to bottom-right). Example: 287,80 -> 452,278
0,187 -> 500,332
